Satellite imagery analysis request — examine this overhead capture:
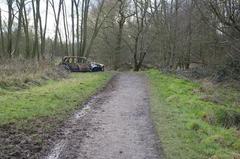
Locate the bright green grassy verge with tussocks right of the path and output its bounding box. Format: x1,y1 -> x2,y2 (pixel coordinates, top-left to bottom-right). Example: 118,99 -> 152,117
147,70 -> 240,159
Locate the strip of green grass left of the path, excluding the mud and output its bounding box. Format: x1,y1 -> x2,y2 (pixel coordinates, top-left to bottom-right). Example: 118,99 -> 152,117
0,73 -> 111,126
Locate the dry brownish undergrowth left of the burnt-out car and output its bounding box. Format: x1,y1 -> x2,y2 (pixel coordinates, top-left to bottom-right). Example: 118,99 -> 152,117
0,59 -> 68,90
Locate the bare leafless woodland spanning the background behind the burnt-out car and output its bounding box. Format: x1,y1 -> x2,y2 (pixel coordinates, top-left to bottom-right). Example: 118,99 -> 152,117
0,0 -> 240,76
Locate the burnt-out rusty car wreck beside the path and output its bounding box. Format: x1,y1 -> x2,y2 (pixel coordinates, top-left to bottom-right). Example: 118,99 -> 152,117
60,56 -> 104,72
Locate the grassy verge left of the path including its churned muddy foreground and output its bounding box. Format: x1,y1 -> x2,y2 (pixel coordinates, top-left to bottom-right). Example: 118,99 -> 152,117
0,73 -> 111,158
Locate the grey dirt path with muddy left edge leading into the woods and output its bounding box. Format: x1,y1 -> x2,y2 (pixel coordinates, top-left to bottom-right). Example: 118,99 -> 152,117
46,73 -> 160,159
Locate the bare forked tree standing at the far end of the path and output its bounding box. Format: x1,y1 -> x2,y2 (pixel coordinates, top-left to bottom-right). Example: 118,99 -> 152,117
125,0 -> 159,71
